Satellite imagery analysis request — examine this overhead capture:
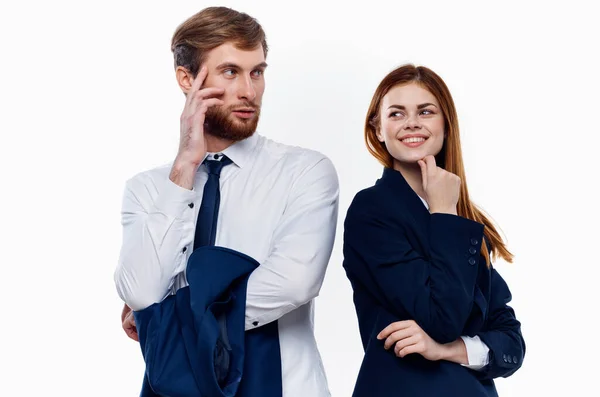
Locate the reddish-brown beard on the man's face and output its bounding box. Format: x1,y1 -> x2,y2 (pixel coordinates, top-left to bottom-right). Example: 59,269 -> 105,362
204,102 -> 260,142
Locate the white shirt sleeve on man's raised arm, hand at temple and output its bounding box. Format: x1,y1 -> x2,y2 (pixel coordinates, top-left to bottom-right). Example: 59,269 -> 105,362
114,174 -> 196,310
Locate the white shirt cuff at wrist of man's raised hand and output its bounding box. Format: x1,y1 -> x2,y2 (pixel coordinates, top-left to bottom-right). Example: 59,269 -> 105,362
154,178 -> 197,220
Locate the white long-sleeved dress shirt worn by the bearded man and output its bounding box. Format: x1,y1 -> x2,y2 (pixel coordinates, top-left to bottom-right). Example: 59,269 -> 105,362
115,133 -> 339,397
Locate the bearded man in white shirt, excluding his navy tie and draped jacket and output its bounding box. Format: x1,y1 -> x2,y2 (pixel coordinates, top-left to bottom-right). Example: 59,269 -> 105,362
115,7 -> 339,397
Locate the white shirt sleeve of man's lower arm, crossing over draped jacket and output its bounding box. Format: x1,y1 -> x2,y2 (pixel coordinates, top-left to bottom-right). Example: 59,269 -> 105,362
246,157 -> 339,330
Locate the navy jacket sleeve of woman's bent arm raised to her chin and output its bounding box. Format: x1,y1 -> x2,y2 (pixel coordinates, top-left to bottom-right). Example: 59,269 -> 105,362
343,199 -> 483,343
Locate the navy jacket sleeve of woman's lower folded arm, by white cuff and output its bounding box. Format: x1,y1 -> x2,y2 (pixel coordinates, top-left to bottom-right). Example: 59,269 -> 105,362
477,268 -> 525,379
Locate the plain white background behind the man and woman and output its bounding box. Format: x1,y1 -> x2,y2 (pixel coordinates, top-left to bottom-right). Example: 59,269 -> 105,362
0,0 -> 600,397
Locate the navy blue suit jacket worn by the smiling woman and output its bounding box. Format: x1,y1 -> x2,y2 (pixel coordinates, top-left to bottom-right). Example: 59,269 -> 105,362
343,168 -> 525,397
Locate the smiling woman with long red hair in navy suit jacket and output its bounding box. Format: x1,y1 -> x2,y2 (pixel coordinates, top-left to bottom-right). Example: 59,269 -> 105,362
344,65 -> 525,397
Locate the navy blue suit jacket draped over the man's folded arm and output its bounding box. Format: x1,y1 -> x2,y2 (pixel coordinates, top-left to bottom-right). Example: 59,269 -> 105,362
134,246 -> 283,397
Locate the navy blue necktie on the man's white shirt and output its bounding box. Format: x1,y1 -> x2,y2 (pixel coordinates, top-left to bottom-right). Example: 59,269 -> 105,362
194,156 -> 231,251
